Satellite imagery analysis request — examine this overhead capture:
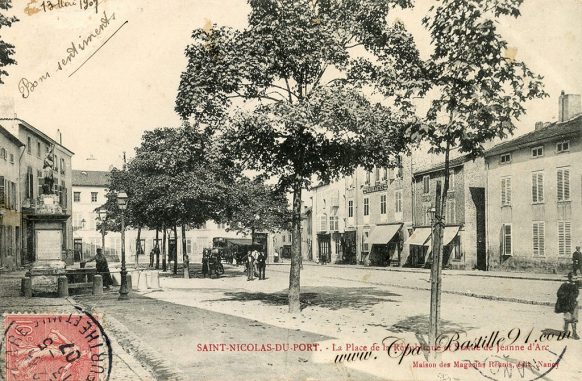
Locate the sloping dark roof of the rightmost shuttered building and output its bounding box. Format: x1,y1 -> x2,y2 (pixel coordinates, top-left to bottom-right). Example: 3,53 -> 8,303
485,115 -> 582,157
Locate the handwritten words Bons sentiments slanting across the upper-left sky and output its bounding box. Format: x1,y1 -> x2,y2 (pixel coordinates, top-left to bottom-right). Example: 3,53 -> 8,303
18,12 -> 115,98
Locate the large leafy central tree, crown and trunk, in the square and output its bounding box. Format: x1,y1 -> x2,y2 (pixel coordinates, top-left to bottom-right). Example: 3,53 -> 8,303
176,0 -> 419,313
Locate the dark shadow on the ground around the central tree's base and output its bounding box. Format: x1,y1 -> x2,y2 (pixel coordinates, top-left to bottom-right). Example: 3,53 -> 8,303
208,287 -> 400,310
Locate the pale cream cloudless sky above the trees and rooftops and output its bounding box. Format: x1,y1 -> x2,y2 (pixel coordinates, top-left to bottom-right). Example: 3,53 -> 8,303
0,0 -> 582,170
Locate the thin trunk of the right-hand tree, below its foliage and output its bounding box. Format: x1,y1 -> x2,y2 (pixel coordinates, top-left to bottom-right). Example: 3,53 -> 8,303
428,181 -> 444,359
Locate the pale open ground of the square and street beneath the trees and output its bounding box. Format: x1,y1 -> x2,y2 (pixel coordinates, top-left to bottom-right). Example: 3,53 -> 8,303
1,264 -> 582,380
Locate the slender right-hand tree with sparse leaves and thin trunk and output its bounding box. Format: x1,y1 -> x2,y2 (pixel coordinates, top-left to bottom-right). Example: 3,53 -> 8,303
409,0 -> 547,341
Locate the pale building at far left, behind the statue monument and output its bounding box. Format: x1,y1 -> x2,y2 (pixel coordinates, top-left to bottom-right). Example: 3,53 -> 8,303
0,118 -> 73,266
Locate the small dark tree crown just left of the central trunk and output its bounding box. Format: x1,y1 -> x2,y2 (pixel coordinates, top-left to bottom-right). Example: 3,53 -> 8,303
227,178 -> 290,242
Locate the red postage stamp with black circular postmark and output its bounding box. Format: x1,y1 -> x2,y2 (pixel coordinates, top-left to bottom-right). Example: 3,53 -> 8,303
0,307 -> 113,381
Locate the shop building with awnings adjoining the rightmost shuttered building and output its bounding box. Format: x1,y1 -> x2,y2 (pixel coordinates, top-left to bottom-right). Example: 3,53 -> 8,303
410,156 -> 486,270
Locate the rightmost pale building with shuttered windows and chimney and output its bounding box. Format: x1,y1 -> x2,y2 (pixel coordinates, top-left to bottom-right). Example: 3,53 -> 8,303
485,93 -> 582,272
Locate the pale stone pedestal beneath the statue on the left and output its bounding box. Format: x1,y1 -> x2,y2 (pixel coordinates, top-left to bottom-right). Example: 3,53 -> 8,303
26,195 -> 69,295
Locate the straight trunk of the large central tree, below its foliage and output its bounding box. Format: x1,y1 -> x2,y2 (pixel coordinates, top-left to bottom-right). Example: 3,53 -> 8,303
289,182 -> 301,313
